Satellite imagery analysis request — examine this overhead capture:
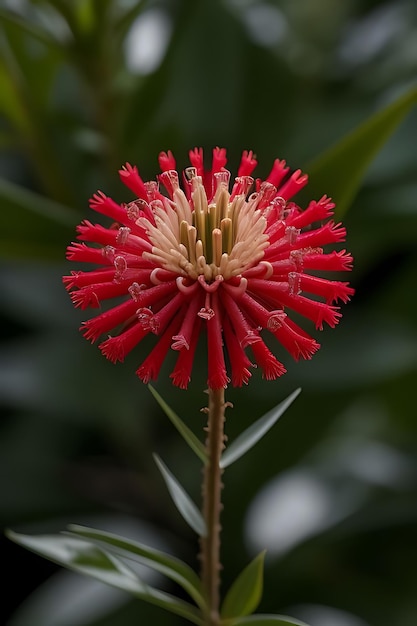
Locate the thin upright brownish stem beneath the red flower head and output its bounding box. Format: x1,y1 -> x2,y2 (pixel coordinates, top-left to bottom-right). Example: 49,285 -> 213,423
201,389 -> 226,626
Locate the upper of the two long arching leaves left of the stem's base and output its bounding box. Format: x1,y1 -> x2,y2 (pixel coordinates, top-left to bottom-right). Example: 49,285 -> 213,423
68,524 -> 206,609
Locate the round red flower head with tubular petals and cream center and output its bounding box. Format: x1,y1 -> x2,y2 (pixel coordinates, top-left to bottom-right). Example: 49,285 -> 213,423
63,148 -> 353,389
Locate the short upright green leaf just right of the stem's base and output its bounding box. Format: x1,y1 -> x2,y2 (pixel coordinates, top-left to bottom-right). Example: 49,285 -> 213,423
221,550 -> 265,623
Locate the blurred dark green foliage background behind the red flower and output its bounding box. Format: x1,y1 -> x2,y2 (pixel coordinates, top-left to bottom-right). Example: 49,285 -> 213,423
0,0 -> 417,626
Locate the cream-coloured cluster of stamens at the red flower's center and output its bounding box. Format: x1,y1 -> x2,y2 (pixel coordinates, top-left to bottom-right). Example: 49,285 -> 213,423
138,176 -> 269,283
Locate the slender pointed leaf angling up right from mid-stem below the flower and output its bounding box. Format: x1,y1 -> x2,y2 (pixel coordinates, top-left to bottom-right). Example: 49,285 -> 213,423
220,388 -> 301,468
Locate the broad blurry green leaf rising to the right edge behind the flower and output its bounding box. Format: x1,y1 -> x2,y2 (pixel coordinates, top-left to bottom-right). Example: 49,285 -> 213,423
305,89 -> 417,217
